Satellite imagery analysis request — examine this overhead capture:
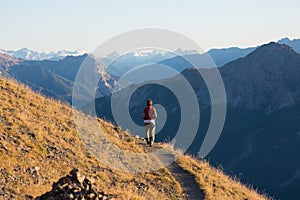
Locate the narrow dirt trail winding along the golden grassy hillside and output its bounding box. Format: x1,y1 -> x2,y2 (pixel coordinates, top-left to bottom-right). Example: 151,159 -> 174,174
137,140 -> 205,200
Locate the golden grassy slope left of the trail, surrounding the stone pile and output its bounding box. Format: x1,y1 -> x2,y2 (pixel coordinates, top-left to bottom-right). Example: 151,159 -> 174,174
0,79 -> 181,199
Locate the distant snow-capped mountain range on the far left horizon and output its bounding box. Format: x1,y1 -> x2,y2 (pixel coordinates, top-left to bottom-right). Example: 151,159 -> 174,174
0,48 -> 86,61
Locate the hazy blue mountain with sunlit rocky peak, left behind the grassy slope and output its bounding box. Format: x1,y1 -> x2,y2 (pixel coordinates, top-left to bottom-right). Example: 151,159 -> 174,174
0,54 -> 116,103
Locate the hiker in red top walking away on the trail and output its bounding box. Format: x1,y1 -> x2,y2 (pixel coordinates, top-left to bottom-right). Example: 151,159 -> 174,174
142,99 -> 157,147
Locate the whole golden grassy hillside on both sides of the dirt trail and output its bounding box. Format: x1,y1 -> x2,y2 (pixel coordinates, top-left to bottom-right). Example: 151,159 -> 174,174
0,78 -> 265,199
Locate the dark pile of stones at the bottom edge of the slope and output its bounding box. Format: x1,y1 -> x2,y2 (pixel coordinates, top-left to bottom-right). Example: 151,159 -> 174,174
36,169 -> 116,200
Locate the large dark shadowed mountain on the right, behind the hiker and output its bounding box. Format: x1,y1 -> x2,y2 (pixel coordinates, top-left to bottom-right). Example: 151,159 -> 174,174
96,42 -> 300,199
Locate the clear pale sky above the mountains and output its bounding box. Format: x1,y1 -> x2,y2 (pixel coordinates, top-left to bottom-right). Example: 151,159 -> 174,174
0,0 -> 300,51
